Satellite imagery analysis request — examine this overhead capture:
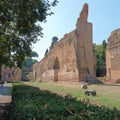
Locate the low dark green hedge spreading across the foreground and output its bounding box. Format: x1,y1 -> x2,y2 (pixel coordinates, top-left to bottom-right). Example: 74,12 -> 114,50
10,85 -> 120,120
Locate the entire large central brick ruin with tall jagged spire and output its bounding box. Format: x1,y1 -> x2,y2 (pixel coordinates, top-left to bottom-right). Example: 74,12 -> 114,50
33,3 -> 96,81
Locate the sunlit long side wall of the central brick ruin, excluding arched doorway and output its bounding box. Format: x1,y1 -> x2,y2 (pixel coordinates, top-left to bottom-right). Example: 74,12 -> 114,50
33,31 -> 78,81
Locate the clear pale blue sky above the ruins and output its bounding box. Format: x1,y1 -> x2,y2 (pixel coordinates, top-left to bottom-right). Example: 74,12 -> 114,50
33,0 -> 120,61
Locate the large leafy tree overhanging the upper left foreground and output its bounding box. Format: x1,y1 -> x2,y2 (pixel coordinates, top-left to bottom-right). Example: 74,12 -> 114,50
0,0 -> 58,67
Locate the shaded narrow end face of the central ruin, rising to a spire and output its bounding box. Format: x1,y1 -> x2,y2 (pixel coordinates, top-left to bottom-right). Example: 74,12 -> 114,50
75,3 -> 95,81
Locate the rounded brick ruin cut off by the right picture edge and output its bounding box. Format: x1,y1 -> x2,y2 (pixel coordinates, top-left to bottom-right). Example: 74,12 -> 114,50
106,29 -> 120,82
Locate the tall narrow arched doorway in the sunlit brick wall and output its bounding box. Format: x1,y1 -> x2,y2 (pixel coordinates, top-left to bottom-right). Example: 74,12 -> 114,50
53,57 -> 60,82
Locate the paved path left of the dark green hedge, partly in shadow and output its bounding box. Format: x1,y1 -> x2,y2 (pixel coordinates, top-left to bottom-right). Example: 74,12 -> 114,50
0,83 -> 11,120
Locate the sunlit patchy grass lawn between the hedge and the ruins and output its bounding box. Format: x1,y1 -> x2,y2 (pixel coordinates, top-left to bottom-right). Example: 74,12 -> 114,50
25,82 -> 120,109
